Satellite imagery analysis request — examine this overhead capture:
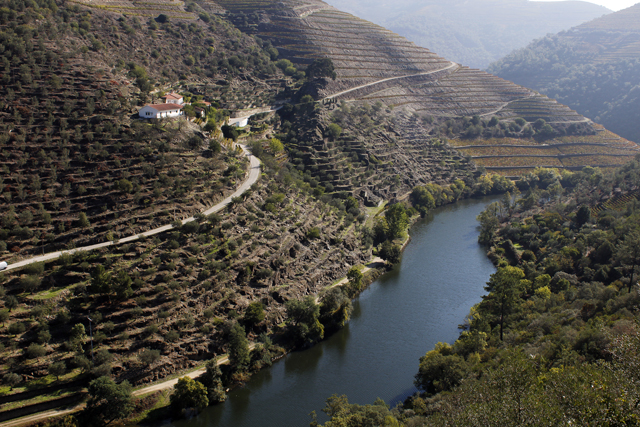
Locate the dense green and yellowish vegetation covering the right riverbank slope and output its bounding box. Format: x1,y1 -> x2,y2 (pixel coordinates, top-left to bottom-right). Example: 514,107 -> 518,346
312,159 -> 640,426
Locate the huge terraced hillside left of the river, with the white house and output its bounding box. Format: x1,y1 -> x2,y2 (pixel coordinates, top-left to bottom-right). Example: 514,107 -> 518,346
0,0 -> 637,424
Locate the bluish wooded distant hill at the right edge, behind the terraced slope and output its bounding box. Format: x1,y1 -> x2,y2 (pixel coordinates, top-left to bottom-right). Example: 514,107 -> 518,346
489,4 -> 640,141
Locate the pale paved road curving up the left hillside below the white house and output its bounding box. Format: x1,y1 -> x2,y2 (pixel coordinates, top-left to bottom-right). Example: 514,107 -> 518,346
3,144 -> 260,271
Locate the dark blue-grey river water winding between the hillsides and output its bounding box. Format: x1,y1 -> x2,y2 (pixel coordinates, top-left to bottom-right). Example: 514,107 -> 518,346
171,198 -> 494,427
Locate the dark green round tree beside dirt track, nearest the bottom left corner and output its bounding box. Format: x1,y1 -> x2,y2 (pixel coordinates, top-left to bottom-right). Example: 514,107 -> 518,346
85,377 -> 134,425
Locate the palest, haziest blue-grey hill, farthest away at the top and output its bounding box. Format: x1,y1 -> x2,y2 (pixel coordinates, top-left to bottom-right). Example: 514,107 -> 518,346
328,0 -> 611,68
